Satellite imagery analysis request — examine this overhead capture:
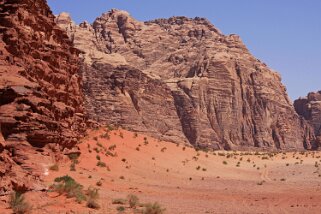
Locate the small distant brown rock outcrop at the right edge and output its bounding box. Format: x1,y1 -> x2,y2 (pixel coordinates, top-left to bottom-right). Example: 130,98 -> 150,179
294,91 -> 321,148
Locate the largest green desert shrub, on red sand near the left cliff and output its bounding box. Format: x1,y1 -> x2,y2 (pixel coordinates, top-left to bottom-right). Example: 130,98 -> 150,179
52,175 -> 86,203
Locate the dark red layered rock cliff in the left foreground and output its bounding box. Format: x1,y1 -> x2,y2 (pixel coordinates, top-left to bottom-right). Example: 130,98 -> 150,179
0,0 -> 84,193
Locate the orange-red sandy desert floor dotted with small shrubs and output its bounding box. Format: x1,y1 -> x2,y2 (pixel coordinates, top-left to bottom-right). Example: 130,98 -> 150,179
0,129 -> 321,214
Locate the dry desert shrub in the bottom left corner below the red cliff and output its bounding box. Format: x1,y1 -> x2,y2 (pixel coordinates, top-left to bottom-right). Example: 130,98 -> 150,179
9,192 -> 32,214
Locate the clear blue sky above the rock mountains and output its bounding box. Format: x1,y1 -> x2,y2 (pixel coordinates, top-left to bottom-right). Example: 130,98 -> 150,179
48,0 -> 321,100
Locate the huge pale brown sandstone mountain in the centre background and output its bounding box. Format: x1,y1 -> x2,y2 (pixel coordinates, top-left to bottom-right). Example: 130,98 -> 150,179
56,10 -> 313,149
